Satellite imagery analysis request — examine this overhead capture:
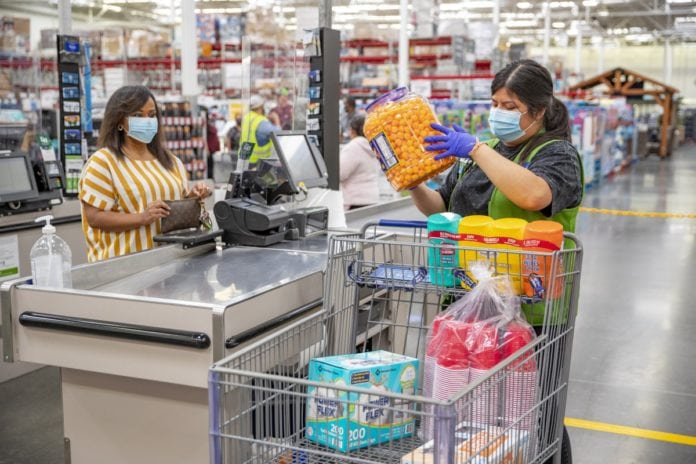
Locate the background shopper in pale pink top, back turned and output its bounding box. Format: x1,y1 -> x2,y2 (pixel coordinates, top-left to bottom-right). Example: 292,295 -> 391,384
339,114 -> 380,210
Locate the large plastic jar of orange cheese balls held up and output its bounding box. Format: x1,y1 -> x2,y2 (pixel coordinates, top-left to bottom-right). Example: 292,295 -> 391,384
364,87 -> 455,192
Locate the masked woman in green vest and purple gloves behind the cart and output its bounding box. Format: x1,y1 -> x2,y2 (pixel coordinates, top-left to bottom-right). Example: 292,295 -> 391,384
412,60 -> 584,236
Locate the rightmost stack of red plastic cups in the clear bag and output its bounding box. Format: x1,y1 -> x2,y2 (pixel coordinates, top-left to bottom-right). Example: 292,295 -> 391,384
500,322 -> 537,432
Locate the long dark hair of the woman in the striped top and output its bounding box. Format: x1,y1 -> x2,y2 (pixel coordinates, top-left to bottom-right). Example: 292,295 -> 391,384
98,85 -> 174,171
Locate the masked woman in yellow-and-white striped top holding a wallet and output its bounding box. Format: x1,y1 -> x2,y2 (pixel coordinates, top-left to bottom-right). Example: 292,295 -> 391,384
79,85 -> 210,261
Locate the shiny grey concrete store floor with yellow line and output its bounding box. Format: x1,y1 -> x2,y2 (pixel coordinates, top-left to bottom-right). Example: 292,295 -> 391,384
0,145 -> 696,464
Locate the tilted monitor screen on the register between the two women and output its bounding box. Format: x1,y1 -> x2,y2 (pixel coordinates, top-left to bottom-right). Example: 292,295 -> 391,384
271,131 -> 329,193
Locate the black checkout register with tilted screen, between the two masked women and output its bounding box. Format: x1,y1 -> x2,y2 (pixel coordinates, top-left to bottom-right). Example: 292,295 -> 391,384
213,131 -> 329,246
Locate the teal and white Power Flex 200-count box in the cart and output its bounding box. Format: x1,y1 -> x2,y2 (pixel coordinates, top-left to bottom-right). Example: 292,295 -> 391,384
305,351 -> 419,452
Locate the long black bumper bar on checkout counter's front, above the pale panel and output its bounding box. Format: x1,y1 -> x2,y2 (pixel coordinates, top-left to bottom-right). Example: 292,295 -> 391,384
19,311 -> 210,350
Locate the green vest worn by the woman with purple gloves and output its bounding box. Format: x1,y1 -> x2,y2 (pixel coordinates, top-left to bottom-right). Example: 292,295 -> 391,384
450,139 -> 585,326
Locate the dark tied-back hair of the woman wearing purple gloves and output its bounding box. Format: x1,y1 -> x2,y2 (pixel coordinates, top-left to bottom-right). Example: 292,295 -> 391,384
491,60 -> 570,147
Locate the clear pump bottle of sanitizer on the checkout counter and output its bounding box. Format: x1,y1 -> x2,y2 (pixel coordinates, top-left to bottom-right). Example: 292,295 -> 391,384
29,215 -> 72,288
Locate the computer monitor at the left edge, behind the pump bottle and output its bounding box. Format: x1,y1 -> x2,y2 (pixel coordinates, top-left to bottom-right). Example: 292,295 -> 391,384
0,151 -> 39,203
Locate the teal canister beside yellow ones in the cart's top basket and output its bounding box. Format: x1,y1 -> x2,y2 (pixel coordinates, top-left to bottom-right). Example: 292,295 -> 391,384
428,213 -> 462,287
